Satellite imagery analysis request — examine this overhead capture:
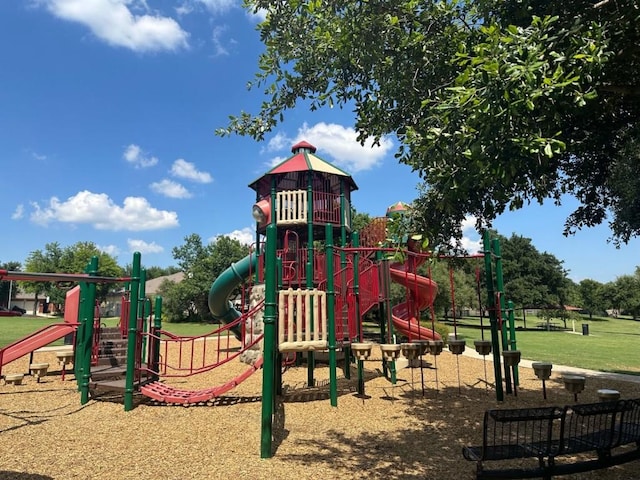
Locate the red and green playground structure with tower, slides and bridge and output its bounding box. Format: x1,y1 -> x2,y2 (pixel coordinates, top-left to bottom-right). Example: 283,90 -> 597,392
0,142 -> 517,457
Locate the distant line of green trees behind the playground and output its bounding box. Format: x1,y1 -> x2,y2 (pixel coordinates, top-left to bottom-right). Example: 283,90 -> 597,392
0,221 -> 640,322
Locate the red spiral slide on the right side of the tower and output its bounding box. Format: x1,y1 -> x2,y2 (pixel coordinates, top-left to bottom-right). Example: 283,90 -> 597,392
389,263 -> 440,340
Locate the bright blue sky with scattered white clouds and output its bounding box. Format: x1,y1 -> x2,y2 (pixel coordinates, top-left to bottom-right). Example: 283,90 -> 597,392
0,0 -> 640,282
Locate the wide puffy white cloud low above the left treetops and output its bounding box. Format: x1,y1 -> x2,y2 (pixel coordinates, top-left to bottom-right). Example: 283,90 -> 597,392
30,190 -> 179,231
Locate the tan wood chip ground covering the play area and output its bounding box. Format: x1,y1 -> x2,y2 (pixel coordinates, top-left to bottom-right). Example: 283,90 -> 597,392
0,344 -> 640,480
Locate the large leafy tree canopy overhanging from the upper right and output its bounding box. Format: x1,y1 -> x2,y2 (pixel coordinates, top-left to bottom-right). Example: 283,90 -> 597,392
218,0 -> 640,246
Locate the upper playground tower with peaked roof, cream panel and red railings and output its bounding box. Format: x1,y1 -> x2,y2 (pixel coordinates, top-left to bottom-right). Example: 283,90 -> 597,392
249,141 -> 358,288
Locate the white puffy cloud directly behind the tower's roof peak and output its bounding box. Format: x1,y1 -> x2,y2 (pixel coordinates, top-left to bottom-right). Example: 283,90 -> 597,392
294,122 -> 393,173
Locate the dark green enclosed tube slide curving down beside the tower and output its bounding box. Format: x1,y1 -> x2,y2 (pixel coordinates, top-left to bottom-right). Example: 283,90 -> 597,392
208,253 -> 258,339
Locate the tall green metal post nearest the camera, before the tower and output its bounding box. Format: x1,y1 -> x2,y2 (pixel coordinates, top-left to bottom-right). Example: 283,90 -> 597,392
260,224 -> 277,458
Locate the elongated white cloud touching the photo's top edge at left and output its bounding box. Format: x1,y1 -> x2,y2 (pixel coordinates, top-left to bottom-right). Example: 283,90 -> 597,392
41,0 -> 189,52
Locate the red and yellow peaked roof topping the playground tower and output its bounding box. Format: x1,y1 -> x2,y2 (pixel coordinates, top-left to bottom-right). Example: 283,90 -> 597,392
249,140 -> 358,190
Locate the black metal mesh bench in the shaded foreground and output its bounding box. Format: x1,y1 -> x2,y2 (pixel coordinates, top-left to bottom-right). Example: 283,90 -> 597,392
462,399 -> 640,479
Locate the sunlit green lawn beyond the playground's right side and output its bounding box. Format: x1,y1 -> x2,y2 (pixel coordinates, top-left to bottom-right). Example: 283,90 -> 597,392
442,317 -> 640,375
